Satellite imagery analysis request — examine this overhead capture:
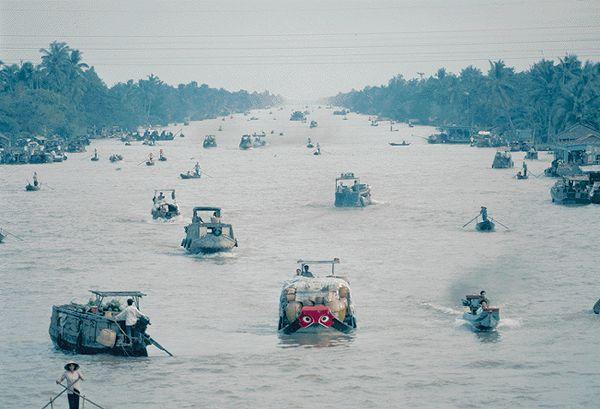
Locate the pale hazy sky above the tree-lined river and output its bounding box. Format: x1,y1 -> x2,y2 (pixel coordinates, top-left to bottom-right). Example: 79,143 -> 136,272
0,0 -> 600,100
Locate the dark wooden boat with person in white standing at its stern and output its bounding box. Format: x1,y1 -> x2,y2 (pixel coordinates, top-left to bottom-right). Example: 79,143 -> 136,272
48,290 -> 152,356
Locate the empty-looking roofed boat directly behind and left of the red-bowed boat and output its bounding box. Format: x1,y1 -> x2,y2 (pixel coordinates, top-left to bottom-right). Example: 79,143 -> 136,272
181,206 -> 238,254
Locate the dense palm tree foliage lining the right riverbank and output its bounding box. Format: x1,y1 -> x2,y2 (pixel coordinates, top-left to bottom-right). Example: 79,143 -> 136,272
331,56 -> 600,140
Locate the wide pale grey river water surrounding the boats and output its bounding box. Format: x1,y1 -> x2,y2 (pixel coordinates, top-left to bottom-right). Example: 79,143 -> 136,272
0,107 -> 600,409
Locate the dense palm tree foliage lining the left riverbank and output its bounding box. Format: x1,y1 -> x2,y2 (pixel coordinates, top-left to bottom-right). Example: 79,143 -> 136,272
0,41 -> 279,138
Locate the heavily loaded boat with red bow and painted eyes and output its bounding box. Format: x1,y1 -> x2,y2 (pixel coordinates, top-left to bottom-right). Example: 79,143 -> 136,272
277,258 -> 356,334
